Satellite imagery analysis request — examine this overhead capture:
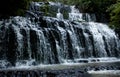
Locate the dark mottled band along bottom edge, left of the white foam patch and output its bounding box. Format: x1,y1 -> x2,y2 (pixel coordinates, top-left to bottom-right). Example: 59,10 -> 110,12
0,69 -> 90,77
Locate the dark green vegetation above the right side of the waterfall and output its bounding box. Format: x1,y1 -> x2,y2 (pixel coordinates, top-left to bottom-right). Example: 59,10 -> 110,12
57,0 -> 120,29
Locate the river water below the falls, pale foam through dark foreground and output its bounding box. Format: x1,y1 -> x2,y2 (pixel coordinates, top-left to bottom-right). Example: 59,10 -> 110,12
0,61 -> 120,77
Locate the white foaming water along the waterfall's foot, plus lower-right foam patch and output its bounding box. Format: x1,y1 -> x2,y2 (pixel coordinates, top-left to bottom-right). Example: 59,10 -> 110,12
1,57 -> 120,70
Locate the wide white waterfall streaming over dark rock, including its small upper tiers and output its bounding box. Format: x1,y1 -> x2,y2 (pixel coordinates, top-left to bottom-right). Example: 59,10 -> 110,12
0,3 -> 120,77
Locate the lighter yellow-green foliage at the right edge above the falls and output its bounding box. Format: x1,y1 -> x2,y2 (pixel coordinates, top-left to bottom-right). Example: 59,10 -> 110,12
108,0 -> 120,28
